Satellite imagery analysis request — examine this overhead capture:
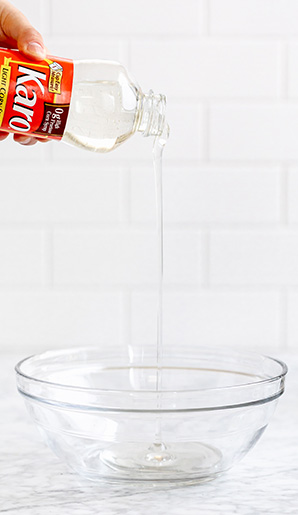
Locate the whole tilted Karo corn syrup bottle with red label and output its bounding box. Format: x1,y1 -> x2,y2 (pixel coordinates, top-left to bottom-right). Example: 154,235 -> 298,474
0,49 -> 166,152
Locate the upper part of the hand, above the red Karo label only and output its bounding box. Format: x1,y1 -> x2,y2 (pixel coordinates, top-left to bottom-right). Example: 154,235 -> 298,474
0,1 -> 46,60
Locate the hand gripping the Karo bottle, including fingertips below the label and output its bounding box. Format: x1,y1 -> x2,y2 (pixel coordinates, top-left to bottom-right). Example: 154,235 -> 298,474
0,0 -> 47,145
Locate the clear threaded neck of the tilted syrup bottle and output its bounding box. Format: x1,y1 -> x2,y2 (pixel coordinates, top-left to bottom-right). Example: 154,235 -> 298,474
137,91 -> 166,137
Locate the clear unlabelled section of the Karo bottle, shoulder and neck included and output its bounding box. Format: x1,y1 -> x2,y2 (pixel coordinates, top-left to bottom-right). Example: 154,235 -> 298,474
63,61 -> 165,152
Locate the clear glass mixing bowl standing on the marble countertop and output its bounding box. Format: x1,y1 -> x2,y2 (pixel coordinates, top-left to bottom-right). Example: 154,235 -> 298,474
16,346 -> 287,483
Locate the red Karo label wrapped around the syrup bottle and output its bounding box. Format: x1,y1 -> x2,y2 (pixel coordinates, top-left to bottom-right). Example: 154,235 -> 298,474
0,48 -> 73,139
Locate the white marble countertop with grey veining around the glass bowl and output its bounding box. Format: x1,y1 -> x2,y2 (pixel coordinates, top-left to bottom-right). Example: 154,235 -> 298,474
0,354 -> 298,515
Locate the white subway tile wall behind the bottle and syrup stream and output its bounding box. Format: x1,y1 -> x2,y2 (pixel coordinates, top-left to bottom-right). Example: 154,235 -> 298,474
0,0 -> 298,355
